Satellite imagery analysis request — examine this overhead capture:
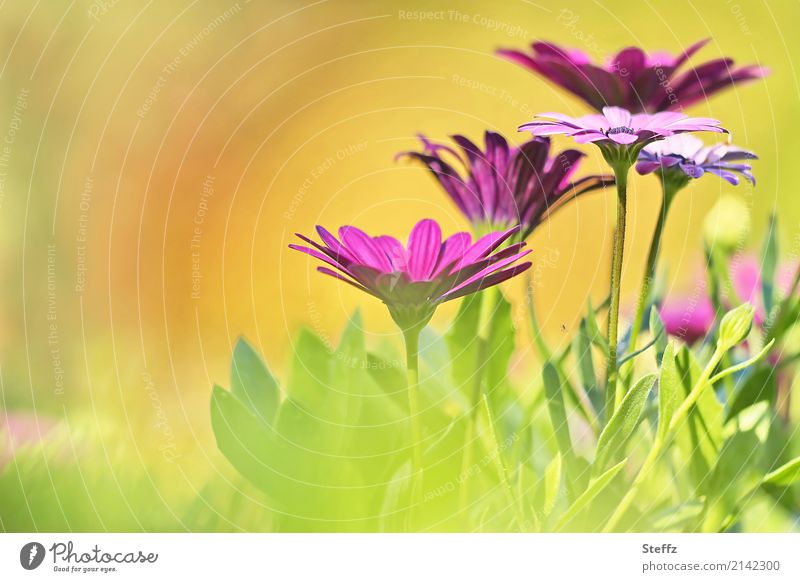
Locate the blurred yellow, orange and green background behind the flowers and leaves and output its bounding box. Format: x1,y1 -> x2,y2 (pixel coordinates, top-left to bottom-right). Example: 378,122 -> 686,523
0,0 -> 800,530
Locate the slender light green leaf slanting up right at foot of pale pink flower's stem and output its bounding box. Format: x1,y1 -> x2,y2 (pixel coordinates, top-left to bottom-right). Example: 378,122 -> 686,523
592,374 -> 656,476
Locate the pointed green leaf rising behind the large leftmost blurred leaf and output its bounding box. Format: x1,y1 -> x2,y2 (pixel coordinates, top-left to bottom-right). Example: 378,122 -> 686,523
231,337 -> 280,424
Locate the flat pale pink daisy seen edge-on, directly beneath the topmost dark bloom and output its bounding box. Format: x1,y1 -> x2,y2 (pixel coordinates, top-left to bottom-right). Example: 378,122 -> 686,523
519,107 -> 727,146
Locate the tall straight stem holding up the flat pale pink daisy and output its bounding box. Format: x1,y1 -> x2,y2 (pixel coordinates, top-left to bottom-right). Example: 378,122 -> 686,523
605,161 -> 630,418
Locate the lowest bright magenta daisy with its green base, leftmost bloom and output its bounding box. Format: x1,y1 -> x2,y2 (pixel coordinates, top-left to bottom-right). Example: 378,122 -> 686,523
289,219 -> 531,330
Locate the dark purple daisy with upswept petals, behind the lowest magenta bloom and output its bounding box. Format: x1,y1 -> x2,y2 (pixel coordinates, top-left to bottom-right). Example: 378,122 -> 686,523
401,131 -> 614,240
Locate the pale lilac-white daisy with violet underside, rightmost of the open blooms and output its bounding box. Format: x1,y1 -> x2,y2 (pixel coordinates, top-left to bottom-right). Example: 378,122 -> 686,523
636,135 -> 758,186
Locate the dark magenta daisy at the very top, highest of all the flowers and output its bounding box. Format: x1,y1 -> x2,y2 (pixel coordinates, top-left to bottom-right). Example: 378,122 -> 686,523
498,39 -> 768,113
